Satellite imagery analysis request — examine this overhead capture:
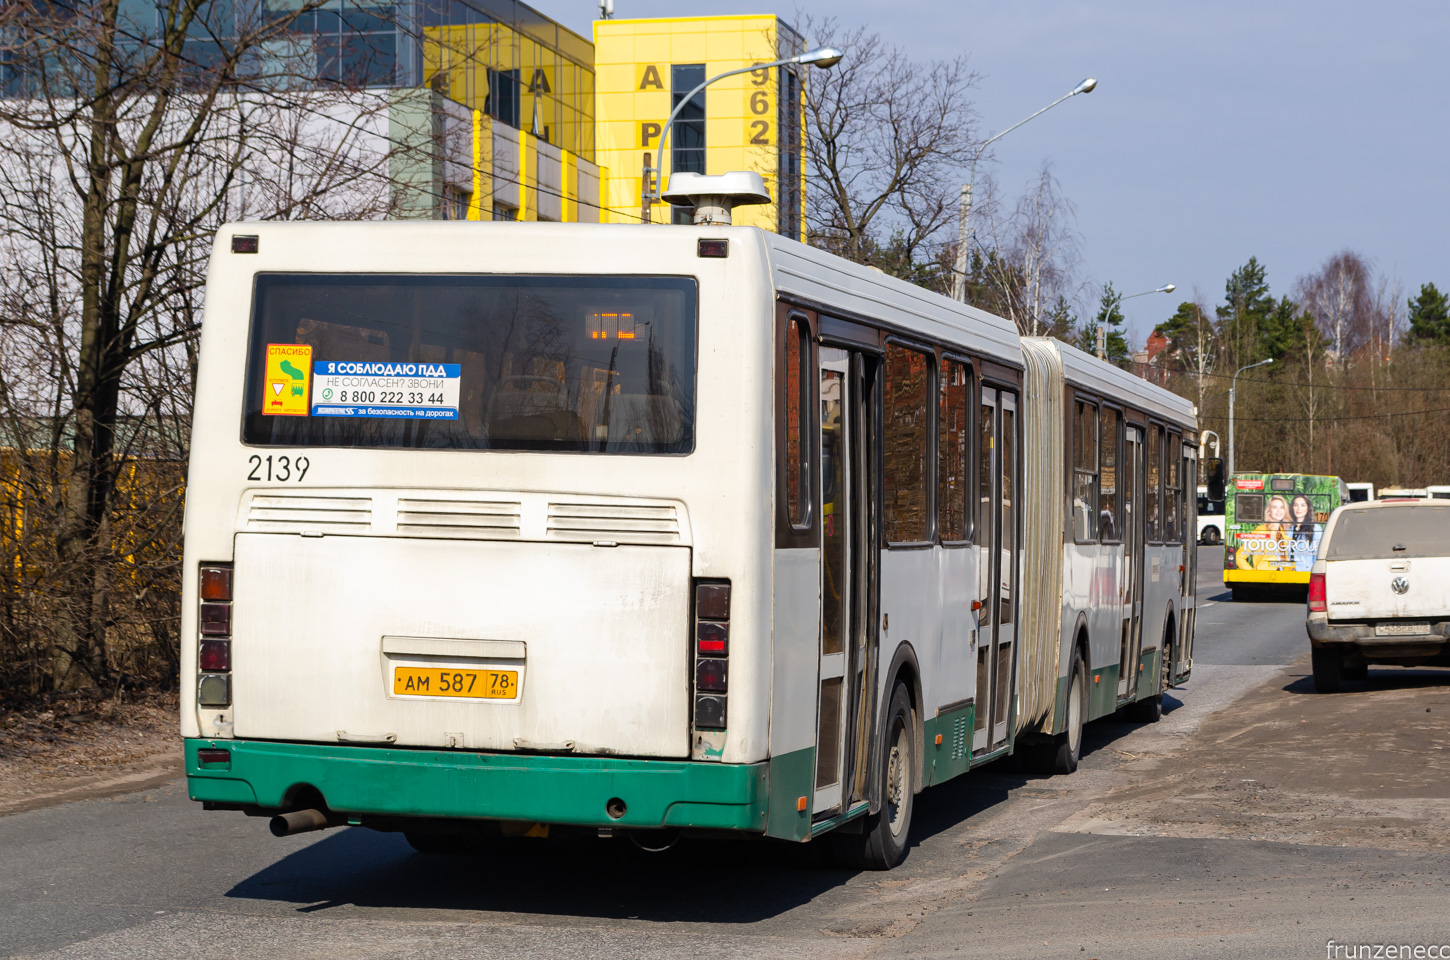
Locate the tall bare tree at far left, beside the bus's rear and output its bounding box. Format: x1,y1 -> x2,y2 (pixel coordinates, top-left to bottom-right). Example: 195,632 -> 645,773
0,0 -> 389,687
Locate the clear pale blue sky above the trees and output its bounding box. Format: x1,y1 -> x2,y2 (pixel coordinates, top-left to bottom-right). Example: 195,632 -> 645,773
553,0 -> 1450,345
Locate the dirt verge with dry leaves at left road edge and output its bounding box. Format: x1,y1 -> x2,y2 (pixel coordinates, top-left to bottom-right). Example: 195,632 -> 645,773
0,693 -> 181,816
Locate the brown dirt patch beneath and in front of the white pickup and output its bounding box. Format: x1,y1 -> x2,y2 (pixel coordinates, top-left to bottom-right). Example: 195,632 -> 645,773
1059,658 -> 1450,851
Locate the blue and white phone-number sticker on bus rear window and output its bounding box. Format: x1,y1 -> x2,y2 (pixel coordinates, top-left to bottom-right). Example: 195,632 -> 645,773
312,360 -> 463,421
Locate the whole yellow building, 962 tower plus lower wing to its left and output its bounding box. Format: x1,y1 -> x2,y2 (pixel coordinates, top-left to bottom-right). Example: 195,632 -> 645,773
378,0 -> 805,239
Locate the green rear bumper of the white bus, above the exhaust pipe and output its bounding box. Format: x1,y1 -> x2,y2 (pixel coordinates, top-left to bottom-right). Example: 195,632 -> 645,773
186,740 -> 769,832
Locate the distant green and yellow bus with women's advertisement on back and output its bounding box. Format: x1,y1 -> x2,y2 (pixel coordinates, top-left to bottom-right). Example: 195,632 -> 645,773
1224,473 -> 1350,600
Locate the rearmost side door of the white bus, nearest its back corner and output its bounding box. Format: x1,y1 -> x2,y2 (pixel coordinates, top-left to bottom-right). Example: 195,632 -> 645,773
811,347 -> 874,814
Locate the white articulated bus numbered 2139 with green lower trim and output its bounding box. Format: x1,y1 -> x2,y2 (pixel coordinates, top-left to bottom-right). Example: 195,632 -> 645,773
181,217 -> 1196,867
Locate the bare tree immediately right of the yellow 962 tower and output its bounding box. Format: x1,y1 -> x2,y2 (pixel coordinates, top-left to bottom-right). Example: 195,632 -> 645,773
800,17 -> 977,274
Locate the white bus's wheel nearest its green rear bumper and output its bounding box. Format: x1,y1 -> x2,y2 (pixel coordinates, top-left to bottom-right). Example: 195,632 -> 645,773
831,683 -> 916,870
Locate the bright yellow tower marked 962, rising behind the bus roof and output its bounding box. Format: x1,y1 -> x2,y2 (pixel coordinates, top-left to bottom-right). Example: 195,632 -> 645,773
595,16 -> 805,239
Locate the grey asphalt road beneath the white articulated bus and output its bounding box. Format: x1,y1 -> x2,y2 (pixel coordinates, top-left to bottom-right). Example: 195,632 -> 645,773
0,548 -> 1450,959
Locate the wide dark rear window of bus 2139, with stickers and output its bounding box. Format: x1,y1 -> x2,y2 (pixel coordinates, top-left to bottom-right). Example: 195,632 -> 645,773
242,274 -> 697,454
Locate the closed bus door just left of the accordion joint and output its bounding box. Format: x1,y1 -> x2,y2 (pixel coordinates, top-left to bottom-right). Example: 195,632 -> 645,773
972,387 -> 1018,753
